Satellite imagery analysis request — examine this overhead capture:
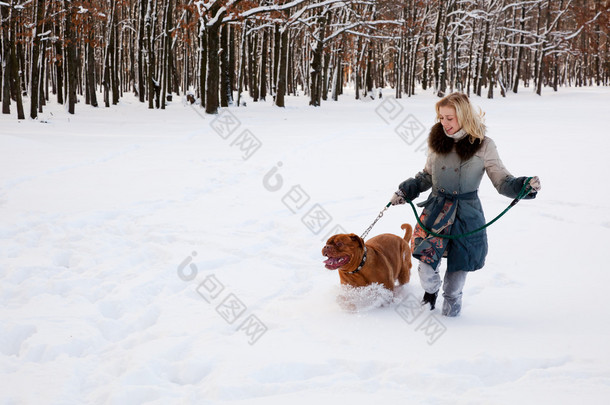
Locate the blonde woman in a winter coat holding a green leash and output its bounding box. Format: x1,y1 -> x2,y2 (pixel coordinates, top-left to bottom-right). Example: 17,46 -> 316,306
391,93 -> 540,316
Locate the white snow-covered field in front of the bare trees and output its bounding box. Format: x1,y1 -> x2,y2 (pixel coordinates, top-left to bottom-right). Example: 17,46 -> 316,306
0,88 -> 610,405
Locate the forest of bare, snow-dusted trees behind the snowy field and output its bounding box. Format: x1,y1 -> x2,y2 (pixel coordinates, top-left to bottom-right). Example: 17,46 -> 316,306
0,0 -> 610,119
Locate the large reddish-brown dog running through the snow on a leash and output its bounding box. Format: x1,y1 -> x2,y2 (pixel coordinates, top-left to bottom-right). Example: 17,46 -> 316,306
322,224 -> 413,291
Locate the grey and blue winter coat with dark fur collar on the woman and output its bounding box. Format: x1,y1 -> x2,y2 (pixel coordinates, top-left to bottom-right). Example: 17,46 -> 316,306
399,123 -> 535,271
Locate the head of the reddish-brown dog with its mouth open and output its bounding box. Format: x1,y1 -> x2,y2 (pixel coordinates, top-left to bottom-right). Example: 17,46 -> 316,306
322,233 -> 364,271
